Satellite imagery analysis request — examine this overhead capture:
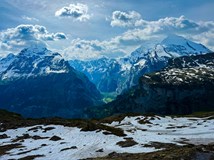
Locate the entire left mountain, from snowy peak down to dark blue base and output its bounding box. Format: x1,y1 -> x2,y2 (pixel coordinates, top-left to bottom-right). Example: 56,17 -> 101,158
0,46 -> 101,117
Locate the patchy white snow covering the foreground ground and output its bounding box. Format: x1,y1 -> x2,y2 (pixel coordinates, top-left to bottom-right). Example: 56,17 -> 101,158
0,116 -> 214,160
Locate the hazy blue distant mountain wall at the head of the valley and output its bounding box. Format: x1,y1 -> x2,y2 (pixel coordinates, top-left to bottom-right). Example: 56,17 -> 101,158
69,58 -> 122,92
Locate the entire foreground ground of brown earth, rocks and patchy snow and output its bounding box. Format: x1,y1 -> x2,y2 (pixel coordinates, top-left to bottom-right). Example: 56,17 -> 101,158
0,111 -> 214,160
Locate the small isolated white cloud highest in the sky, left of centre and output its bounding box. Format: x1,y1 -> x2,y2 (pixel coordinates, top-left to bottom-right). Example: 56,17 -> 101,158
55,3 -> 91,21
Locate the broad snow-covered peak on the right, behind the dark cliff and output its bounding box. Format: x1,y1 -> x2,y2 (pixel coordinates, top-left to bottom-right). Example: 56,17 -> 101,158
129,34 -> 211,63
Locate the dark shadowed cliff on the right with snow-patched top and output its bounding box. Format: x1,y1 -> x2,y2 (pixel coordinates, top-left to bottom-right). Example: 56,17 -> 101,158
90,53 -> 214,117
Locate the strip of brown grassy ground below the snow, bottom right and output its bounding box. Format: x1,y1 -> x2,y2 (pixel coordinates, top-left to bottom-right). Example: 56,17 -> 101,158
87,145 -> 214,160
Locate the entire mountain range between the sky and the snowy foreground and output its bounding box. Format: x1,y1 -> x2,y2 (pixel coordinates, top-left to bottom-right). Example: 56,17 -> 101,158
0,35 -> 214,118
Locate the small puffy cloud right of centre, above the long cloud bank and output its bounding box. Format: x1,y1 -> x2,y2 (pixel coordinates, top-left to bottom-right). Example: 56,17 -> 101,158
111,11 -> 141,27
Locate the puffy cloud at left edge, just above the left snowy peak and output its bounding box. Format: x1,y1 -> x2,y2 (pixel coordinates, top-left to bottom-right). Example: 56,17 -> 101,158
0,24 -> 66,51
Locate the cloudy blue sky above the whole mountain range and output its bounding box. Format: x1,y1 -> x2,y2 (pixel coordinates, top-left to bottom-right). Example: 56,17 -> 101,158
0,0 -> 214,59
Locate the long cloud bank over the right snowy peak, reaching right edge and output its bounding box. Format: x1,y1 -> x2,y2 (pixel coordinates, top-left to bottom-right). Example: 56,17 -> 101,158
108,16 -> 214,48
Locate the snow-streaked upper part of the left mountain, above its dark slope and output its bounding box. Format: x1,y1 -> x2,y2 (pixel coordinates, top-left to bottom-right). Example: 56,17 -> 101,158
0,45 -> 70,80
